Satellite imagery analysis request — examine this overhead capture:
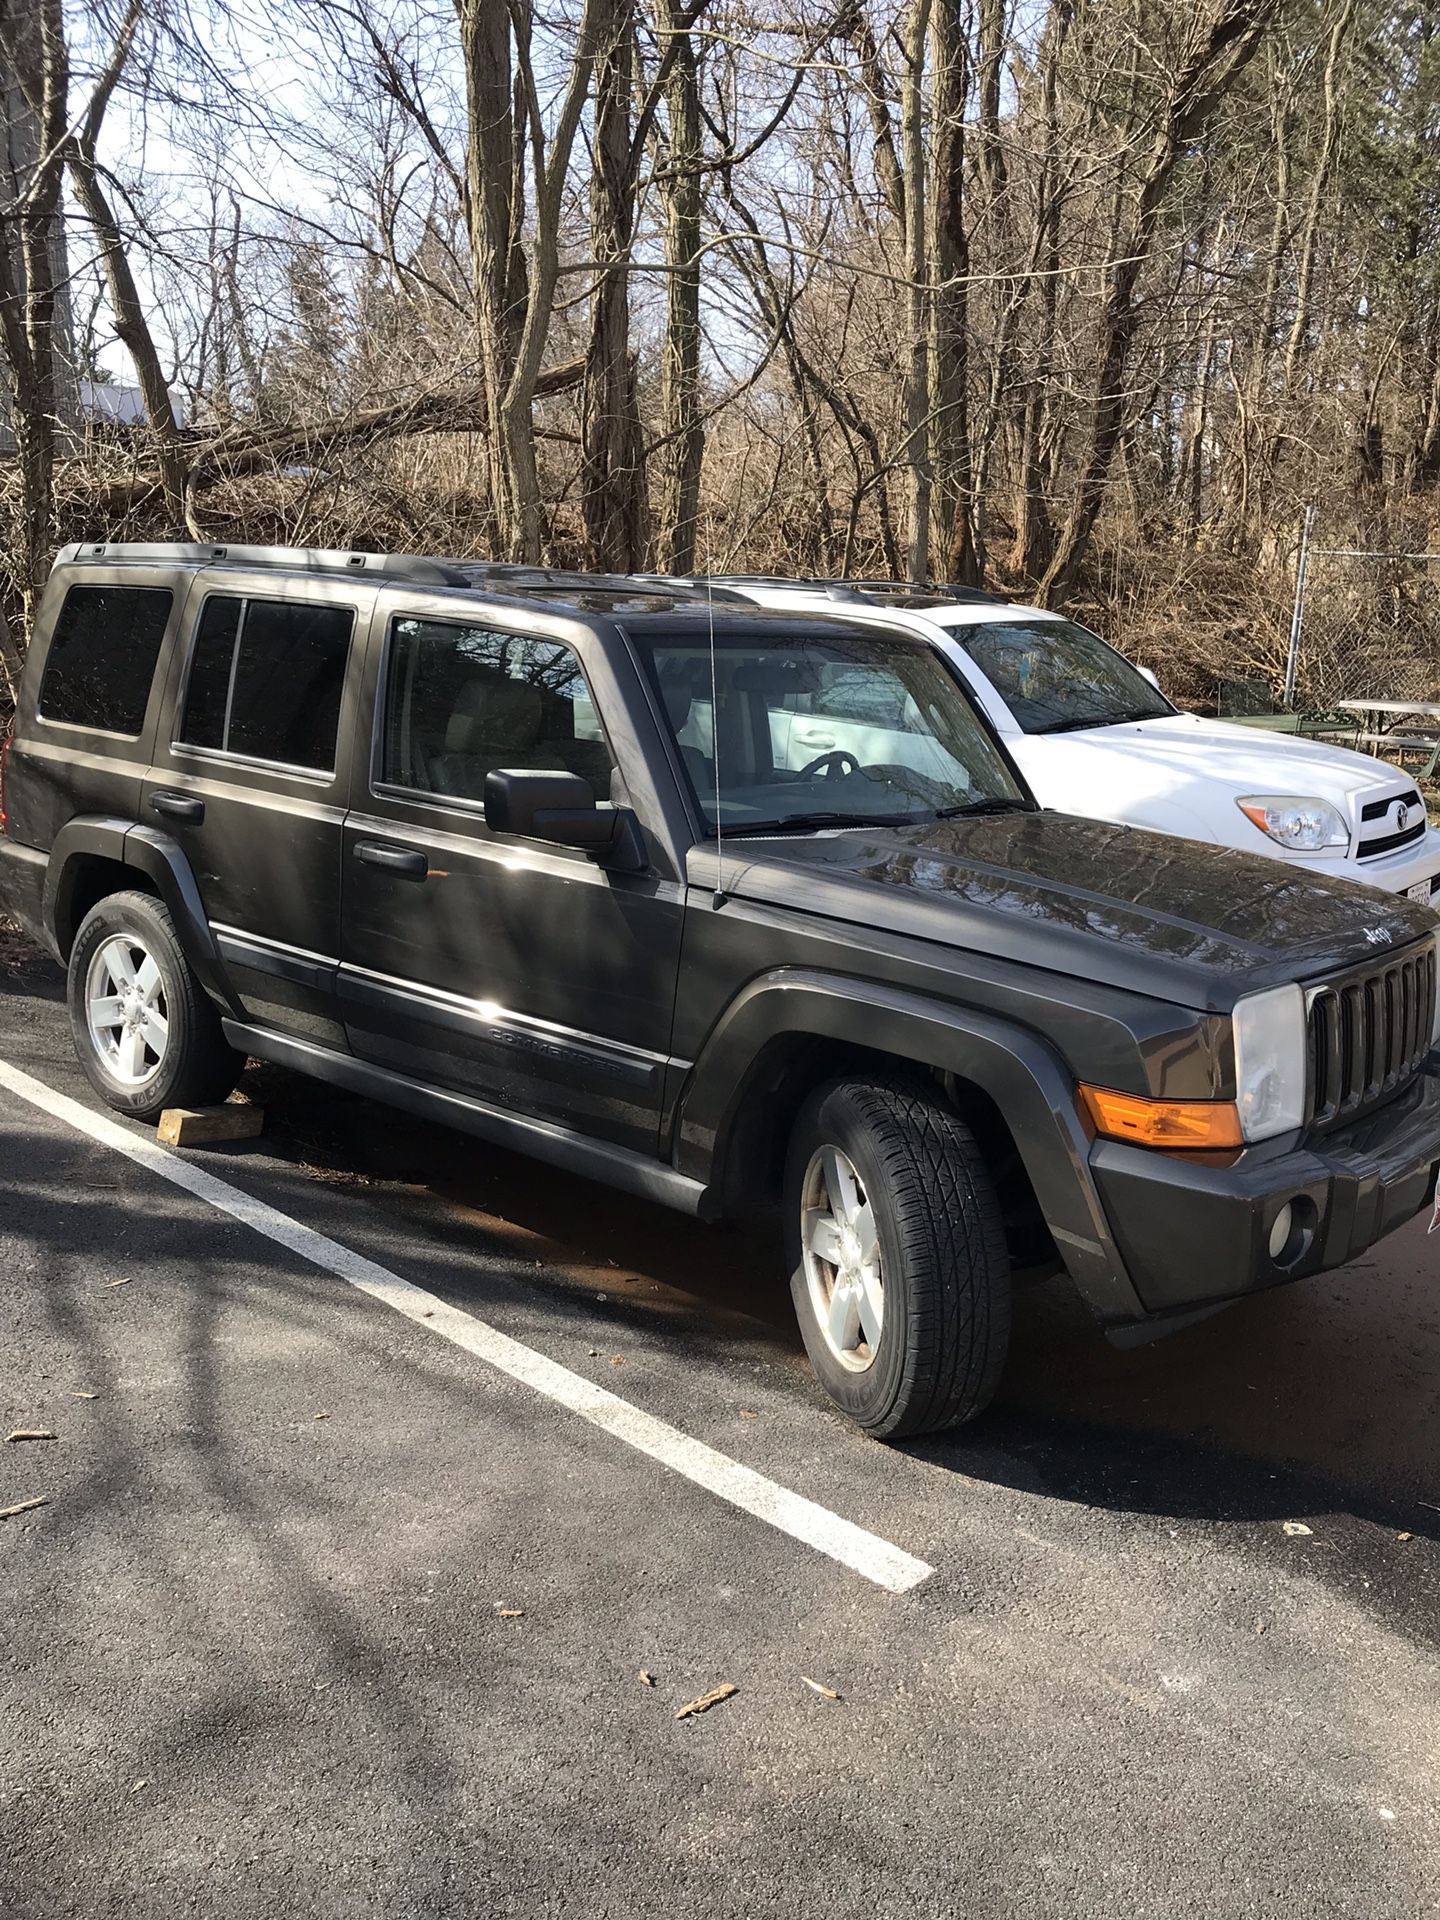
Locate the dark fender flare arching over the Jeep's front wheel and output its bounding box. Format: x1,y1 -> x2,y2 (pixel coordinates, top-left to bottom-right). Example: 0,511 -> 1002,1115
676,968 -> 1144,1321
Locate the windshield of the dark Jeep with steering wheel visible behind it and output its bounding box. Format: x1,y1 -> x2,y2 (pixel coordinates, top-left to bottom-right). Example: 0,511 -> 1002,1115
632,630 -> 1031,833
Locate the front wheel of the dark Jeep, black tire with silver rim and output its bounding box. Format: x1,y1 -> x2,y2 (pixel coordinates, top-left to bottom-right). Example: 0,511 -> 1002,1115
785,1079 -> 1010,1440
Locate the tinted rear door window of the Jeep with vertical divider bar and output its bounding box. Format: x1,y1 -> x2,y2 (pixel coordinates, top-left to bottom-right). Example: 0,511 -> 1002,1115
179,593 -> 355,774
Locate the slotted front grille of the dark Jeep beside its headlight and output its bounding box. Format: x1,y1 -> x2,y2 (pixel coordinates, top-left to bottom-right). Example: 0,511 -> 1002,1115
1306,941 -> 1436,1127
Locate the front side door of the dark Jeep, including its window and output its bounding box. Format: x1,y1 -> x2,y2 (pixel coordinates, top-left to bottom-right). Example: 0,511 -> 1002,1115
340,612 -> 682,1152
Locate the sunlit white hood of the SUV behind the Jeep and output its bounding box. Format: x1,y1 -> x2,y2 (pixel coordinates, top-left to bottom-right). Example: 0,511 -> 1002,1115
1008,714 -> 1415,831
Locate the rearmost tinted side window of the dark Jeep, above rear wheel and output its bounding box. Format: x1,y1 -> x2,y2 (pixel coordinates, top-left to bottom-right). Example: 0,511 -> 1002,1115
40,588 -> 173,739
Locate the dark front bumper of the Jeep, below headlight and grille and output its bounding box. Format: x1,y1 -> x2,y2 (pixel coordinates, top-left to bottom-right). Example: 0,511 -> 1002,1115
1091,1054 -> 1440,1315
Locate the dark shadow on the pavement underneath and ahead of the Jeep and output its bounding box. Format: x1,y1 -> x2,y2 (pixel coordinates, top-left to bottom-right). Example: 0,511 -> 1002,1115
237,1068 -> 1440,1538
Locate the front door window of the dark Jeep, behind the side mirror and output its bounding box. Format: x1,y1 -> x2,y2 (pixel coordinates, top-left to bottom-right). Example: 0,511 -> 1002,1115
380,618 -> 614,803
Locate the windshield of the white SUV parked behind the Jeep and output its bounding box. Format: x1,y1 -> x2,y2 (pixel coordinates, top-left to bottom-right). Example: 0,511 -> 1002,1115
948,620 -> 1175,733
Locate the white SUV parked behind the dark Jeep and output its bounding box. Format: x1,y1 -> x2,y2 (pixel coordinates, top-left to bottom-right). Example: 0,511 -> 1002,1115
712,576 -> 1440,904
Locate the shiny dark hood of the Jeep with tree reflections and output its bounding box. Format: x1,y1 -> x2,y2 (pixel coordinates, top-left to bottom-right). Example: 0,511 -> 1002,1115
689,812 -> 1436,1012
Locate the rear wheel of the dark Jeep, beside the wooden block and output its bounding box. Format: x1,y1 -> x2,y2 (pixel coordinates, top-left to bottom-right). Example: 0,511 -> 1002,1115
67,893 -> 246,1119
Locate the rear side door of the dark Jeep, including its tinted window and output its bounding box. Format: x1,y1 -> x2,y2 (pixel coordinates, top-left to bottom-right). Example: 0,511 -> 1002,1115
140,570 -> 374,1044
